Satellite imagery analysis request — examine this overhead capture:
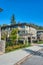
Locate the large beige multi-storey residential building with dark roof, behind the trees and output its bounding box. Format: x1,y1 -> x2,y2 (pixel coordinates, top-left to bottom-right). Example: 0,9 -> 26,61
1,23 -> 37,43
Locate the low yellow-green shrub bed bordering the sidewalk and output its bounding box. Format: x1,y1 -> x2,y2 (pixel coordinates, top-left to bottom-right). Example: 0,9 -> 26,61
5,43 -> 30,52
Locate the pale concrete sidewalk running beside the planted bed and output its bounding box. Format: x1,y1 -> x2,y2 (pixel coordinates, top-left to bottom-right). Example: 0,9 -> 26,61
0,46 -> 41,65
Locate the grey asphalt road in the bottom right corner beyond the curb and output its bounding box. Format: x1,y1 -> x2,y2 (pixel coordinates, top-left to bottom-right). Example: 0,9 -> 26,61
21,50 -> 43,65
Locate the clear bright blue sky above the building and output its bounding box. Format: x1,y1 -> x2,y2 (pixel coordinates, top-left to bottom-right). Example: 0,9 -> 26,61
0,0 -> 43,26
